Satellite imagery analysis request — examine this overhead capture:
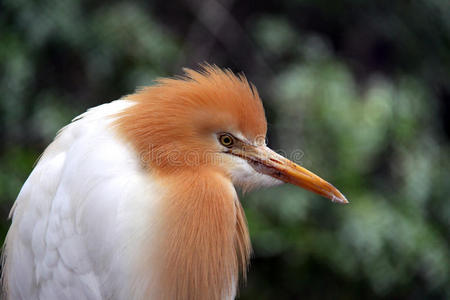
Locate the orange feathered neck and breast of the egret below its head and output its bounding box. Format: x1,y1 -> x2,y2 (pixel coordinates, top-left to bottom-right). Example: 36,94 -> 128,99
141,171 -> 251,299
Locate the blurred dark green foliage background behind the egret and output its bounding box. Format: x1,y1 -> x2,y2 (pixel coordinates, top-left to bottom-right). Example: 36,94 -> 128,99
0,0 -> 450,299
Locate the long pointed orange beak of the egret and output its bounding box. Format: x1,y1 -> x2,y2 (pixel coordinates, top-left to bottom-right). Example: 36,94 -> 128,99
231,144 -> 348,204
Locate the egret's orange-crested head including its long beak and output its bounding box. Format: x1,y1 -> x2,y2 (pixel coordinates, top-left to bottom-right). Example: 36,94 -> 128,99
117,65 -> 348,203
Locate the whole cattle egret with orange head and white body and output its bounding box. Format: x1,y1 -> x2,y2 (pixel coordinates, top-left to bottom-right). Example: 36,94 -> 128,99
3,65 -> 347,300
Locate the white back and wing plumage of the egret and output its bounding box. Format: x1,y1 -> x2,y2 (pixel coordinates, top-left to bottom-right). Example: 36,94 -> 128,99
5,100 -> 160,300
